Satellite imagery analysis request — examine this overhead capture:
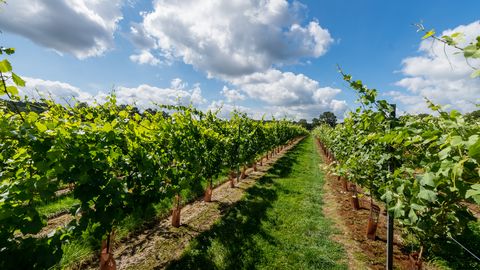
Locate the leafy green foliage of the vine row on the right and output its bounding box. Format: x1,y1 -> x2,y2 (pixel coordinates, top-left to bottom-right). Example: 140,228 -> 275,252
315,70 -> 480,255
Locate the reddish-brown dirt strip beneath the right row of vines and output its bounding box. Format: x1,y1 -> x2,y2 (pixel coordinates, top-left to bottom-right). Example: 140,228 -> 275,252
316,139 -> 415,269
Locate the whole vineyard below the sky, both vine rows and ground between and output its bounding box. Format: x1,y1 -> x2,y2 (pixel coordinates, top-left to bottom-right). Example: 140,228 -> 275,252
0,70 -> 480,269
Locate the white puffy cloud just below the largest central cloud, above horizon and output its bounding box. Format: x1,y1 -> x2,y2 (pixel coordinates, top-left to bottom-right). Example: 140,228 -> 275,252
209,69 -> 347,120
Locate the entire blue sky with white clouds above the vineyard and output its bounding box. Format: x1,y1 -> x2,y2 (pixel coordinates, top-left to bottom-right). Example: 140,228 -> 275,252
0,0 -> 480,121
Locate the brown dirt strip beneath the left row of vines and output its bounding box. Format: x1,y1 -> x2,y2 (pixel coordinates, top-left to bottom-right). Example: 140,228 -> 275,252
81,140 -> 304,269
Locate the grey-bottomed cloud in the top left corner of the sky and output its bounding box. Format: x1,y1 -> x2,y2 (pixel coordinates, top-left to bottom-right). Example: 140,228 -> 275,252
0,0 -> 124,59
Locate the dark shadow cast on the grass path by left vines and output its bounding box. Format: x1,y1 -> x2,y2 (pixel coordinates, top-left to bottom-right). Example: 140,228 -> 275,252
167,141 -> 305,269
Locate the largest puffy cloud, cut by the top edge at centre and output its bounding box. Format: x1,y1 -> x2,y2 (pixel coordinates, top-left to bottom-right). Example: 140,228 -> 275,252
134,0 -> 333,78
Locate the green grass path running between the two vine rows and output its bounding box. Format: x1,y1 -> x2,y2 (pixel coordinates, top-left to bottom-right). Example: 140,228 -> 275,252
168,137 -> 347,269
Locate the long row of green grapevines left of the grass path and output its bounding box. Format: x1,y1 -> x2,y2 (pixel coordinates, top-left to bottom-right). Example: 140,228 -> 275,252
0,82 -> 306,269
